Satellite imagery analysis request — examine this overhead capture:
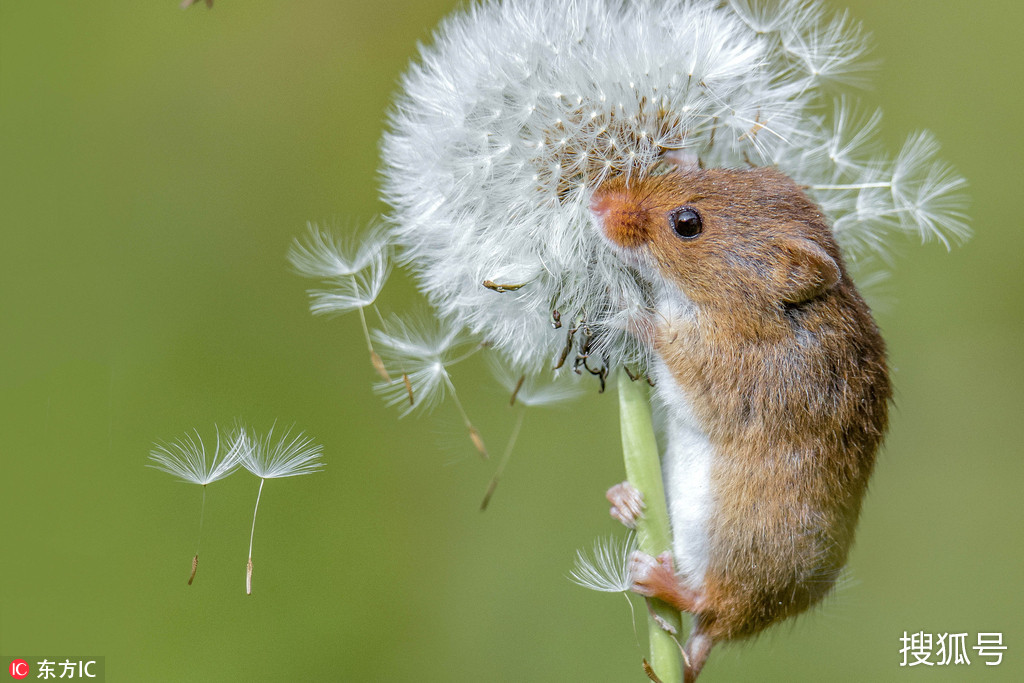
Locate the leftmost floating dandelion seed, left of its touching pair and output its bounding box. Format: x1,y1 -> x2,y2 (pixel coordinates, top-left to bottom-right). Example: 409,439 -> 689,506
150,429 -> 244,586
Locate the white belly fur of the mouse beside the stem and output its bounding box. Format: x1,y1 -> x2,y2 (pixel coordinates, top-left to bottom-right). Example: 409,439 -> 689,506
653,358 -> 715,590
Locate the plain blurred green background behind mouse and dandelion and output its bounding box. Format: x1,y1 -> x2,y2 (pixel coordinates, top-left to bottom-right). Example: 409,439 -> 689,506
0,0 -> 1024,683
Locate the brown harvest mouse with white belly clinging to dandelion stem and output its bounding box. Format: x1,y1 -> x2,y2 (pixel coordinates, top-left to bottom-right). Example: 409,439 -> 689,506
591,165 -> 891,682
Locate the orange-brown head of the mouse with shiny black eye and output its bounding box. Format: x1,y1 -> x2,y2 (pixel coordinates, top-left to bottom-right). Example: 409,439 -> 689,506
591,168 -> 844,310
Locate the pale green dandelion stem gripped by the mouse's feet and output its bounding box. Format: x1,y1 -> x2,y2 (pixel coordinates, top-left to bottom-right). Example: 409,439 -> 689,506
618,372 -> 683,683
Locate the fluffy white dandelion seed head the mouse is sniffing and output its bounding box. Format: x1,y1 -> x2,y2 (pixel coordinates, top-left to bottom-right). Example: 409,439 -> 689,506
378,0 -> 966,378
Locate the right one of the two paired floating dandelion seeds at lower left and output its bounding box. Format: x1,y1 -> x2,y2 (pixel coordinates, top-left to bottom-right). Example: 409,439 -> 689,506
238,427 -> 324,595
